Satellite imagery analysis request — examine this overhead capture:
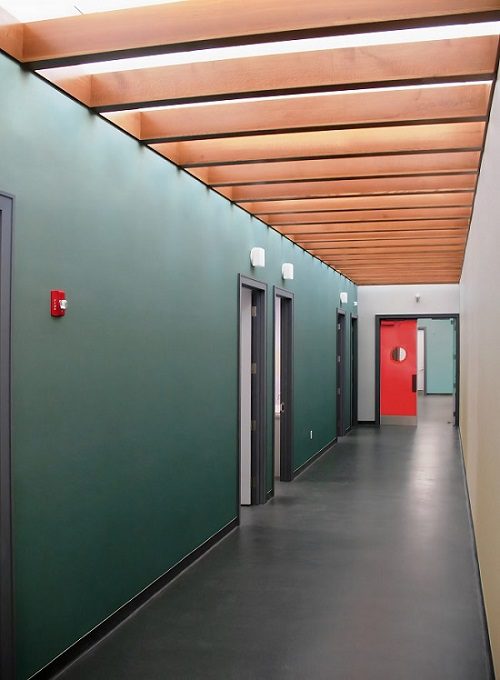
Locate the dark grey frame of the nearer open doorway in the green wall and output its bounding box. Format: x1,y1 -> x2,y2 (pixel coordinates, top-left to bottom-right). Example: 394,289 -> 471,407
236,274 -> 267,522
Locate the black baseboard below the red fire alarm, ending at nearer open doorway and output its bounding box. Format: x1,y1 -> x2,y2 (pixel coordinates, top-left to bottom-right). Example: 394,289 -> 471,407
29,517 -> 238,680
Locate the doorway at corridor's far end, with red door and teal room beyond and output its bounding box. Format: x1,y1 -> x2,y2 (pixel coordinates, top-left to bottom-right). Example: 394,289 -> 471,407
375,314 -> 460,425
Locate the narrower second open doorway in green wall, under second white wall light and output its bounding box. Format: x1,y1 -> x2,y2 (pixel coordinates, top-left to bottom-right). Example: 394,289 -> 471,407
273,286 -> 293,482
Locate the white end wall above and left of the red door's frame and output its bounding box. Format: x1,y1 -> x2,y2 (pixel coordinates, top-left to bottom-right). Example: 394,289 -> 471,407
358,284 -> 459,421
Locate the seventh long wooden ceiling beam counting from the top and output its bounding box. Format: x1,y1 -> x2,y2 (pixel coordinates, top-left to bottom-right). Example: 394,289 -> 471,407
239,191 -> 474,214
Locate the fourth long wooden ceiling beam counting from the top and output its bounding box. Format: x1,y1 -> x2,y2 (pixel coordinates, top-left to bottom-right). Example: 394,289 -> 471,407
151,123 -> 485,168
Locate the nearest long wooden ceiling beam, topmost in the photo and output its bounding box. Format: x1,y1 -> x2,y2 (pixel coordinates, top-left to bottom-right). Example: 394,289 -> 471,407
19,0 -> 500,68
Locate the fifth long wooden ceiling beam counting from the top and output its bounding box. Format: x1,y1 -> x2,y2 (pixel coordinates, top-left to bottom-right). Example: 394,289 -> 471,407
188,151 -> 480,187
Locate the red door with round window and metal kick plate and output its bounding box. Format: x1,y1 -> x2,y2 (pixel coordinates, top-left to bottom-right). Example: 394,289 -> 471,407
380,319 -> 417,425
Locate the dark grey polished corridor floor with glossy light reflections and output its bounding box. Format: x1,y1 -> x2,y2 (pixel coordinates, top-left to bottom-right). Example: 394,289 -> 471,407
59,397 -> 493,680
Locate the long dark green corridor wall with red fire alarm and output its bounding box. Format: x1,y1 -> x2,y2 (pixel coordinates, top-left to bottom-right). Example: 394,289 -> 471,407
0,56 -> 356,679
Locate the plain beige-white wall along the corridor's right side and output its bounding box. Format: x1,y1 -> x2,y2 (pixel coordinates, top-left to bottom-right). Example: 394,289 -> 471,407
460,75 -> 500,674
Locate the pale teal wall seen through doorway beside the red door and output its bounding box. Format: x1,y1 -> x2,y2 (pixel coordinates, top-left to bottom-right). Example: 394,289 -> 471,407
418,319 -> 455,394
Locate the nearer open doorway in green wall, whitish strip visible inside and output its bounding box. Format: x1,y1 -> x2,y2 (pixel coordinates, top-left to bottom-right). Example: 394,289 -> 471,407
238,275 -> 267,509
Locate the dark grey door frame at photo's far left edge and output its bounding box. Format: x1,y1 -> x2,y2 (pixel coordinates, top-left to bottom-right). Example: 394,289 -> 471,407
0,193 -> 14,680
